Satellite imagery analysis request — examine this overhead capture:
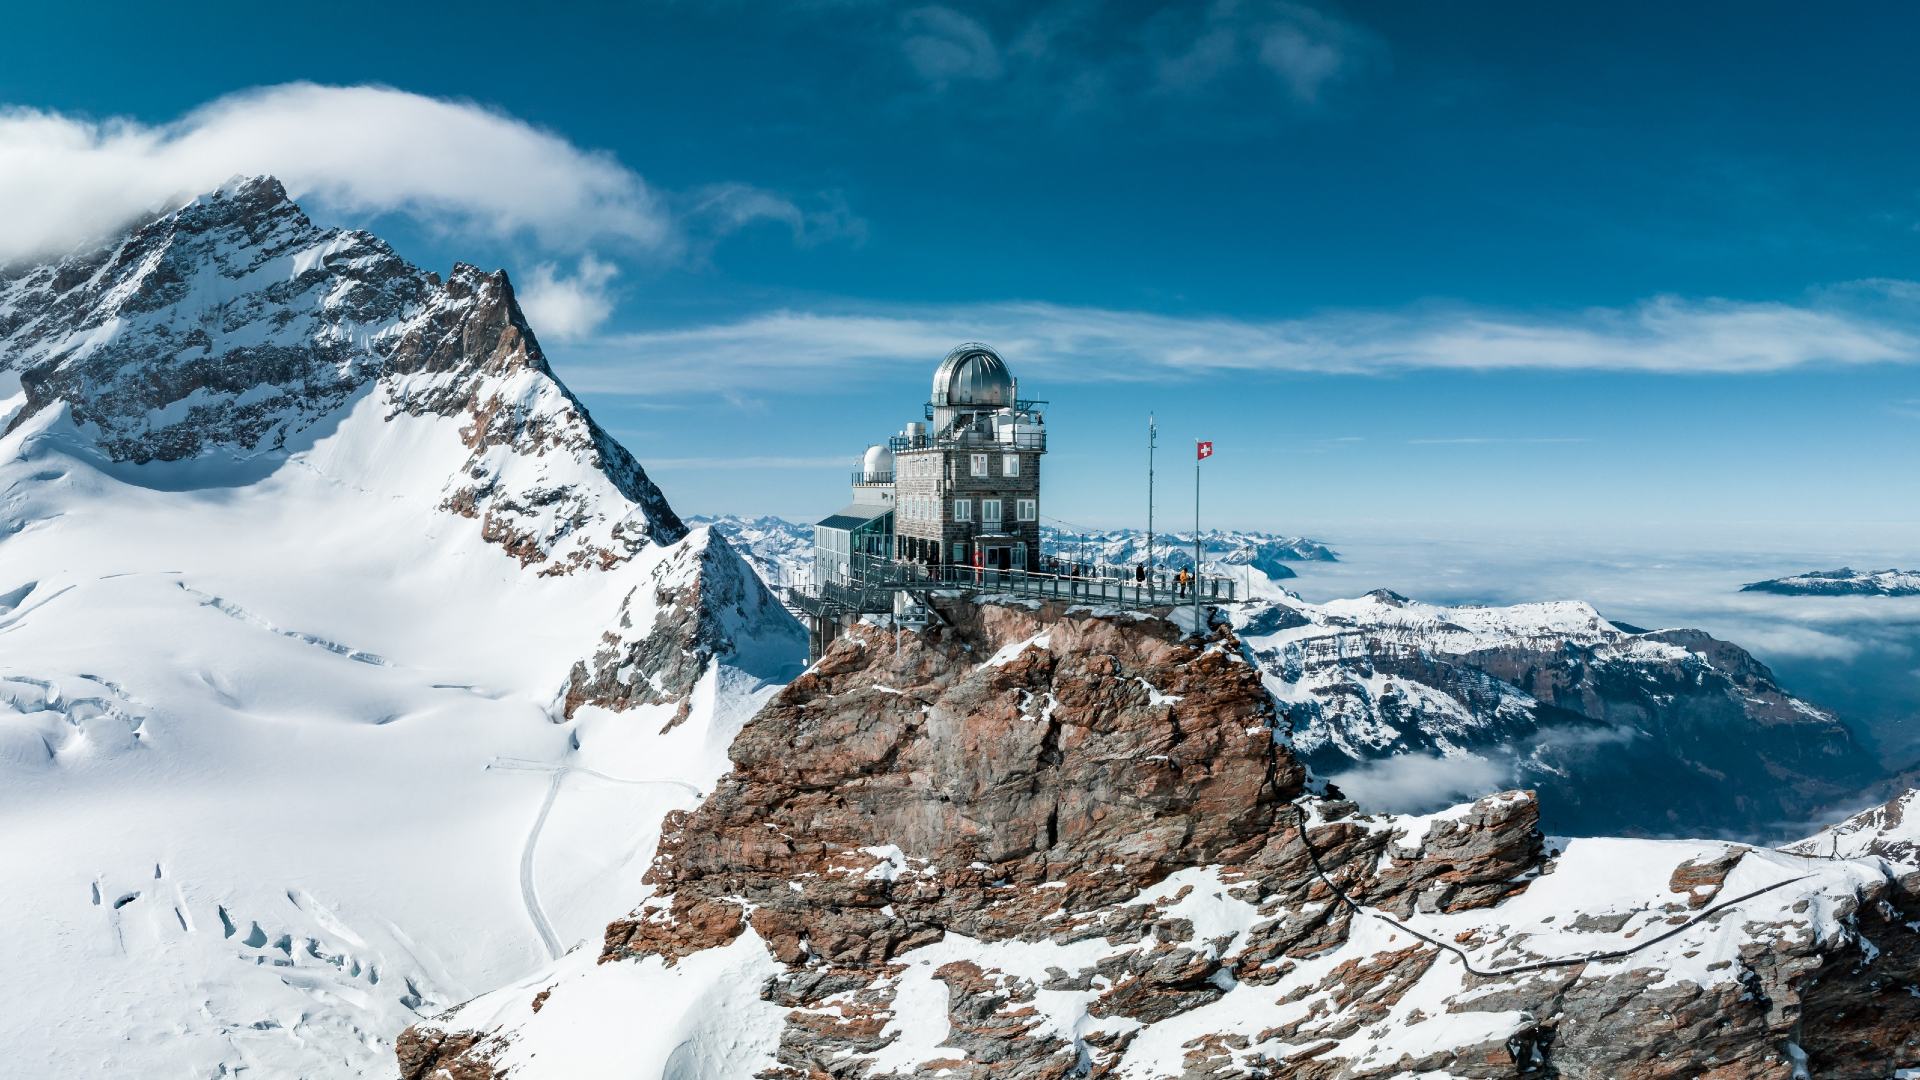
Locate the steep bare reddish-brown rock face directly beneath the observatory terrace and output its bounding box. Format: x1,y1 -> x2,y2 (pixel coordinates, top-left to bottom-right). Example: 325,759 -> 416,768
607,603 -> 1304,965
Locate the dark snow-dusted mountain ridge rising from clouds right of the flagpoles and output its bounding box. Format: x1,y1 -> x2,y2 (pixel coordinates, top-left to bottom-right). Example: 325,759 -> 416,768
1235,592 -> 1878,836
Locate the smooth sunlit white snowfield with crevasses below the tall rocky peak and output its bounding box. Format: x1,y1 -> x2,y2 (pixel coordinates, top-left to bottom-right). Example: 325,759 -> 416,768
0,384 -> 794,1078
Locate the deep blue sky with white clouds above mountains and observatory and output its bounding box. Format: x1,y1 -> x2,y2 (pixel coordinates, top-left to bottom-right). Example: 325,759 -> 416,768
0,0 -> 1920,538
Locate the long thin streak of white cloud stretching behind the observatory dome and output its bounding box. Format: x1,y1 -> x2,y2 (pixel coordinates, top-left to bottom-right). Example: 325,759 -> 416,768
552,290 -> 1920,392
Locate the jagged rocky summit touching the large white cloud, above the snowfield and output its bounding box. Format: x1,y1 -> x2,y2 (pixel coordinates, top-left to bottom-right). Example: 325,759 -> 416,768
0,177 -> 685,573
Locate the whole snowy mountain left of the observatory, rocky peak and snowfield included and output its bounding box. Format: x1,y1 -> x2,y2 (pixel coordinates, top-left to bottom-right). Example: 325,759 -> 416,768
0,181 -> 804,1076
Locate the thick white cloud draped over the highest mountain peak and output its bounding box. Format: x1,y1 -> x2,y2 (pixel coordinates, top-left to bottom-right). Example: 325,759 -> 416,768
0,83 -> 845,263
